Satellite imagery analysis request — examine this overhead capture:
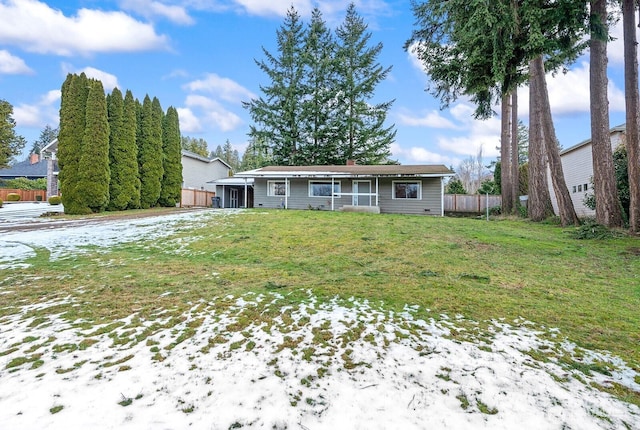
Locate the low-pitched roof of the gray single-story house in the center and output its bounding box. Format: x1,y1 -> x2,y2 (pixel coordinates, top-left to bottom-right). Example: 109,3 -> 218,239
235,164 -> 453,178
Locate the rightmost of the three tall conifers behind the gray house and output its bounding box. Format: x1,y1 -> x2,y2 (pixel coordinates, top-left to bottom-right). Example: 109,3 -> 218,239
336,3 -> 396,164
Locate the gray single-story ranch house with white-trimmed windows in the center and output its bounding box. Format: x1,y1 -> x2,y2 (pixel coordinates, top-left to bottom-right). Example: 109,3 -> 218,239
235,165 -> 453,216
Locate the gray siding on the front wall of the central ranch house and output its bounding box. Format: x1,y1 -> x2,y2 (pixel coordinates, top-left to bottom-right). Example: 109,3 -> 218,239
254,178 -> 442,216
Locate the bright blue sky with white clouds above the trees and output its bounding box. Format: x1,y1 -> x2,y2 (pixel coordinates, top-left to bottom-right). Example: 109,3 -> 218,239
0,0 -> 624,167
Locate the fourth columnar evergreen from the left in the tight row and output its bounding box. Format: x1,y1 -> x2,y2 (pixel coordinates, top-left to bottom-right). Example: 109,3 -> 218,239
120,90 -> 140,209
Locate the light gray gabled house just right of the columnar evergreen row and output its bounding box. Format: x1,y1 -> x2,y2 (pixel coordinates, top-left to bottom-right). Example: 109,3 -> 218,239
182,149 -> 232,191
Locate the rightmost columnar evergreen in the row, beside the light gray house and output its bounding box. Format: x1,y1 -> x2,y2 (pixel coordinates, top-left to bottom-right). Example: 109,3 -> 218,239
159,106 -> 182,207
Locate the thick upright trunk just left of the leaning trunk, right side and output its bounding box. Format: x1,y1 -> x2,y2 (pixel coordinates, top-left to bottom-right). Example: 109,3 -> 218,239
527,60 -> 553,221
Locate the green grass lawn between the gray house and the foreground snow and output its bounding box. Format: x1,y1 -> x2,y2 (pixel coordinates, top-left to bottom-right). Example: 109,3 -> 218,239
0,210 -> 640,394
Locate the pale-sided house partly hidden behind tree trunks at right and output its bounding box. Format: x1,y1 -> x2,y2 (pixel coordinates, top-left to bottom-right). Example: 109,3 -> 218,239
547,124 -> 626,217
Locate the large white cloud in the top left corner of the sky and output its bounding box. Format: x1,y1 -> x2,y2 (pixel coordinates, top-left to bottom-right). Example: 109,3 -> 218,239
0,0 -> 168,56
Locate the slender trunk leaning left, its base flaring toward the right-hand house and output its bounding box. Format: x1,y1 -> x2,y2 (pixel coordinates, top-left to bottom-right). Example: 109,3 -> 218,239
532,56 -> 580,227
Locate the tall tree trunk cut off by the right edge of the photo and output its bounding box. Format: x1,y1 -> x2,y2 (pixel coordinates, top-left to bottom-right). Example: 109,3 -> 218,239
622,0 -> 640,233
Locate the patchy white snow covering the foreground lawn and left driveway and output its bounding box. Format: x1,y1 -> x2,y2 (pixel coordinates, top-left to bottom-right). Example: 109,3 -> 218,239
0,210 -> 640,430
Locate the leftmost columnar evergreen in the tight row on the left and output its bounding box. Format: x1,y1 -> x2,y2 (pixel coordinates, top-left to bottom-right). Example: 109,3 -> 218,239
57,73 -> 89,214
